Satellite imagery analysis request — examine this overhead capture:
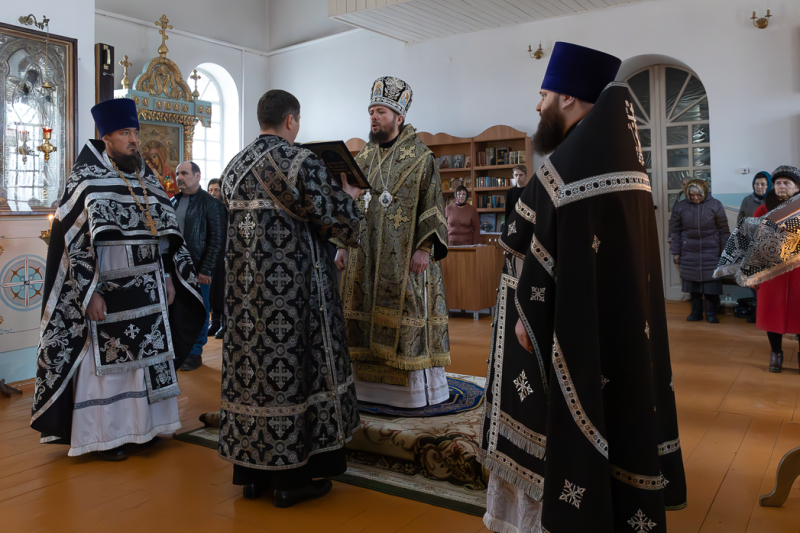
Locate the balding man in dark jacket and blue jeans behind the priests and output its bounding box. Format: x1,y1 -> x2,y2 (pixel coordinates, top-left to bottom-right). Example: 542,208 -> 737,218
172,161 -> 225,371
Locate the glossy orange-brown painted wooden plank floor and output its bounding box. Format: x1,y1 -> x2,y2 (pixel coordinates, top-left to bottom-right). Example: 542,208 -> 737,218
0,303 -> 800,533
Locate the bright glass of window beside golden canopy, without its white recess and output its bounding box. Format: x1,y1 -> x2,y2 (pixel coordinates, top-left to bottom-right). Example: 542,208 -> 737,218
192,69 -> 225,190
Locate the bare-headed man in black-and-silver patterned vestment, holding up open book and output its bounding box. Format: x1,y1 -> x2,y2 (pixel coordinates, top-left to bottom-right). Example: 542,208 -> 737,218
219,90 -> 361,507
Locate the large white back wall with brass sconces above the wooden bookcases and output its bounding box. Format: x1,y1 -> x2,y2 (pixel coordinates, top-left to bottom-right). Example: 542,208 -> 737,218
270,0 -> 800,205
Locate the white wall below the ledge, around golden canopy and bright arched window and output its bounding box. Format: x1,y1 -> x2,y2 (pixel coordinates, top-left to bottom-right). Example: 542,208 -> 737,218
92,11 -> 269,144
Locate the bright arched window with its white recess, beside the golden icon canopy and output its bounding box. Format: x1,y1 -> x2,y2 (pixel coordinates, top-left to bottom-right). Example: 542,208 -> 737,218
192,63 -> 241,190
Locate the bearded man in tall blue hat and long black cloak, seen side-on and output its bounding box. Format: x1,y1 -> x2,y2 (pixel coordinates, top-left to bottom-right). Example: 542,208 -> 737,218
482,43 -> 686,533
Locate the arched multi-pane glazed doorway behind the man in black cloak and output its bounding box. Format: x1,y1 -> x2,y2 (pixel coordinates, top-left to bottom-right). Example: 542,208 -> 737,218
625,65 -> 711,298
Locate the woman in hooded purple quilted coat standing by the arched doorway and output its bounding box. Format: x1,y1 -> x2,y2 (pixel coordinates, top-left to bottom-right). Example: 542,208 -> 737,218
670,179 -> 731,324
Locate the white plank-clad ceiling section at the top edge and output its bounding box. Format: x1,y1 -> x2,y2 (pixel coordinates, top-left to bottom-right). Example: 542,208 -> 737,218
328,0 -> 648,43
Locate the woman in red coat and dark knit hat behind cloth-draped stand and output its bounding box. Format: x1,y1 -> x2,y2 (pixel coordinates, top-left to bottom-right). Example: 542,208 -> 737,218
753,166 -> 800,372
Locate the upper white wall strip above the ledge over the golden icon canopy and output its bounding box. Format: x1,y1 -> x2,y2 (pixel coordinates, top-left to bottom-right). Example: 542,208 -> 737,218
95,0 -> 267,50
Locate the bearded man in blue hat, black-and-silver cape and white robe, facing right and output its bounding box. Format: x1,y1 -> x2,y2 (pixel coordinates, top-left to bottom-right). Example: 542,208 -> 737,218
31,98 -> 204,461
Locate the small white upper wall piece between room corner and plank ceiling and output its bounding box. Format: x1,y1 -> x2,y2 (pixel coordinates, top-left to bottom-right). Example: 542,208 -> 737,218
265,0 -> 352,50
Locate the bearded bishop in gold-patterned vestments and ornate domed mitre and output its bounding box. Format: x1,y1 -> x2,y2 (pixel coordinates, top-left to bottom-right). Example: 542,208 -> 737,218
337,77 -> 450,408
